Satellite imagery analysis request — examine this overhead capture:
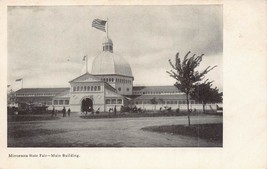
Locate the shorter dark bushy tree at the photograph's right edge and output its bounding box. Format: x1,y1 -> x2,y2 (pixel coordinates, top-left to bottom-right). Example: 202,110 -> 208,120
190,80 -> 222,113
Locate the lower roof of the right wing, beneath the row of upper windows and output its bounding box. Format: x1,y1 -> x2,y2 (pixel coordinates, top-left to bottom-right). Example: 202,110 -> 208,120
134,94 -> 186,100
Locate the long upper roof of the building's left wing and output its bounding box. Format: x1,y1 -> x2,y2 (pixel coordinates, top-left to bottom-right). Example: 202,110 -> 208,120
16,87 -> 70,93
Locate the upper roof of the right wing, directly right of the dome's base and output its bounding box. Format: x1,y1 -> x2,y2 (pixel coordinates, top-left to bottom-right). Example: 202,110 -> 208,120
133,86 -> 180,92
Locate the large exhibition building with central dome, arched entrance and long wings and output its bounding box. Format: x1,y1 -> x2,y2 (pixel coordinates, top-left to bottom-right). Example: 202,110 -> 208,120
15,37 -> 202,112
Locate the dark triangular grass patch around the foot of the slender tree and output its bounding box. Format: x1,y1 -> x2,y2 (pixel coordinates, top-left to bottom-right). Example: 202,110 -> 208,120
142,124 -> 223,143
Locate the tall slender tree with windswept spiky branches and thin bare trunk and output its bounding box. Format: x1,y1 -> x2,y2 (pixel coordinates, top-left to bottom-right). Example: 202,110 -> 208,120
167,51 -> 216,126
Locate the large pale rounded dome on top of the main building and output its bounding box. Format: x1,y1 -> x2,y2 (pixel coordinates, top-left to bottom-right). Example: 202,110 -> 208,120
91,51 -> 133,77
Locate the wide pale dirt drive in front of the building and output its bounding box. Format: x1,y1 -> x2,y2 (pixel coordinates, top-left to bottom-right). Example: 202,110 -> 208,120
8,114 -> 222,147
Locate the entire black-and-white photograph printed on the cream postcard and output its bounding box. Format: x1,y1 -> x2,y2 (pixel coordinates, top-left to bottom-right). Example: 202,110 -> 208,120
7,5 -> 223,148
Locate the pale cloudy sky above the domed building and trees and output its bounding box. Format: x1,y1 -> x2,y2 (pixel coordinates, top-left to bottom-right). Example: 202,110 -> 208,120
7,5 -> 223,91
